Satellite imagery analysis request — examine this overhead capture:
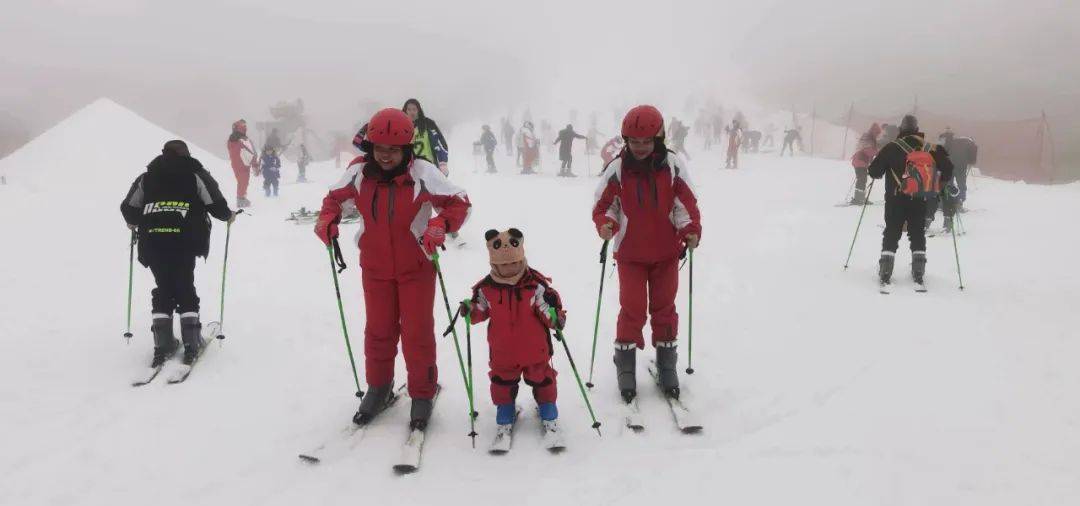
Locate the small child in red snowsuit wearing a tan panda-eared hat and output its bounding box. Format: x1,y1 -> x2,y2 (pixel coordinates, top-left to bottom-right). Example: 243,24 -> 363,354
460,229 -> 566,430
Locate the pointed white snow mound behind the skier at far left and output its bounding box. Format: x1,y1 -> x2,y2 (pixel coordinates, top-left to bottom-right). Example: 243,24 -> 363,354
0,98 -> 225,194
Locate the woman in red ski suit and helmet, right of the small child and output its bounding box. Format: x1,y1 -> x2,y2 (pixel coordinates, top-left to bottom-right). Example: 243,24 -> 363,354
593,106 -> 701,402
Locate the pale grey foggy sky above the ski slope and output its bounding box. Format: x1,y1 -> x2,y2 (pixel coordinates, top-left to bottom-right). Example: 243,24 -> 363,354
0,0 -> 1080,155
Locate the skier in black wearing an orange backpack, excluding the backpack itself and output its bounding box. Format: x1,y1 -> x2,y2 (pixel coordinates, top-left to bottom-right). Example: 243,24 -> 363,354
867,114 -> 953,285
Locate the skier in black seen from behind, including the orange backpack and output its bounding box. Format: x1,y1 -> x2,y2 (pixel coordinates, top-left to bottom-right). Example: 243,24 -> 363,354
867,114 -> 953,293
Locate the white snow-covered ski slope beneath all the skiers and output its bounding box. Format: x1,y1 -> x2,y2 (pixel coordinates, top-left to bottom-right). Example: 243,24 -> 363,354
0,110 -> 1080,506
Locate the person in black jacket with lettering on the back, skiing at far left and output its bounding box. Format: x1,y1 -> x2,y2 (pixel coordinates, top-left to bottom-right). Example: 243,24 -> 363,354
120,140 -> 237,368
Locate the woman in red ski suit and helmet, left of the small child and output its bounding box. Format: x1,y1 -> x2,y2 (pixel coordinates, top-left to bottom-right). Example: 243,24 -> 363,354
315,109 -> 470,428
